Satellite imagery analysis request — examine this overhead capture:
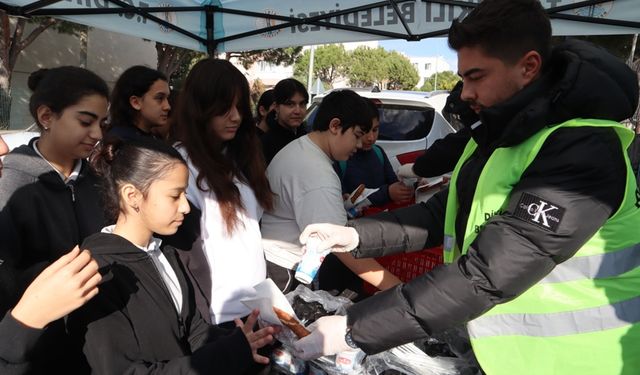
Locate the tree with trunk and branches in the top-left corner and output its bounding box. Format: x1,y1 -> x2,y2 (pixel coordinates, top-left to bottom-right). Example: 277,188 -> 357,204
0,10 -> 88,129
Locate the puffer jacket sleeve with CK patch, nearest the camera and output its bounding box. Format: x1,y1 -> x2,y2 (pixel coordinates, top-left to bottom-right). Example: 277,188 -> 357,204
348,130 -> 626,354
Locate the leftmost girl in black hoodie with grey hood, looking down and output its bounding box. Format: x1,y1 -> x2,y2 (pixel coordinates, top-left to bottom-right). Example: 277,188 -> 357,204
0,66 -> 109,373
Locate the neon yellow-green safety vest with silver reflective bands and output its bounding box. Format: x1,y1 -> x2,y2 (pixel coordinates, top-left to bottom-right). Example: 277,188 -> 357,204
444,119 -> 640,375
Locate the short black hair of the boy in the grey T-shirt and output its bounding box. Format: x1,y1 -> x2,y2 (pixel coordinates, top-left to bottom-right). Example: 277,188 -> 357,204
313,90 -> 371,133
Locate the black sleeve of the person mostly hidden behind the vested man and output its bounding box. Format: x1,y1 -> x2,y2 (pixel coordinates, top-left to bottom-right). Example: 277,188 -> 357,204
413,128 -> 471,177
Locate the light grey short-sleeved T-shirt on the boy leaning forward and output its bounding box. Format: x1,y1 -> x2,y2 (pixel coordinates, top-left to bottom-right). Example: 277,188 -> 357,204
262,135 -> 347,269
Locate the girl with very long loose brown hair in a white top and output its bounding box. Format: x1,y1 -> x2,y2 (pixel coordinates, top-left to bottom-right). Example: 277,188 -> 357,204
175,59 -> 273,324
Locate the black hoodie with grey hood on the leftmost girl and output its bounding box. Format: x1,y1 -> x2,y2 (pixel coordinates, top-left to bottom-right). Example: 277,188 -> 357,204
0,138 -> 105,374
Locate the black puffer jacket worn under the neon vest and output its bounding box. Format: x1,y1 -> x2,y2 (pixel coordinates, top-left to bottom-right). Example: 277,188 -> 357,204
348,41 -> 638,353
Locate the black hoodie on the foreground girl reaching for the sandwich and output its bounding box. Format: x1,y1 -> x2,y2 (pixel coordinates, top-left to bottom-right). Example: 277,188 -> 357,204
67,233 -> 253,374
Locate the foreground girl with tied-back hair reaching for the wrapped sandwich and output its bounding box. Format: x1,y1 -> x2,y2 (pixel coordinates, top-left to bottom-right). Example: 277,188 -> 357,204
68,140 -> 275,374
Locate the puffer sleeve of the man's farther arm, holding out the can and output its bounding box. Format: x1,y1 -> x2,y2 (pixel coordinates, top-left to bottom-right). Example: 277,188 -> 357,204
347,190 -> 448,258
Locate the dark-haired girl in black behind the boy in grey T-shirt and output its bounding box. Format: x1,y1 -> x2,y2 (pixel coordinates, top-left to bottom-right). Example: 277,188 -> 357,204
261,78 -> 309,164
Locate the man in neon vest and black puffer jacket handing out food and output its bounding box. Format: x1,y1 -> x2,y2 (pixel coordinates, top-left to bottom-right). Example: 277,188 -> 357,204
295,0 -> 640,375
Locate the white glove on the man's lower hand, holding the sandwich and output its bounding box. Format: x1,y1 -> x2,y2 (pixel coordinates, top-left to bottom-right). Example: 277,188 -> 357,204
293,315 -> 353,360
